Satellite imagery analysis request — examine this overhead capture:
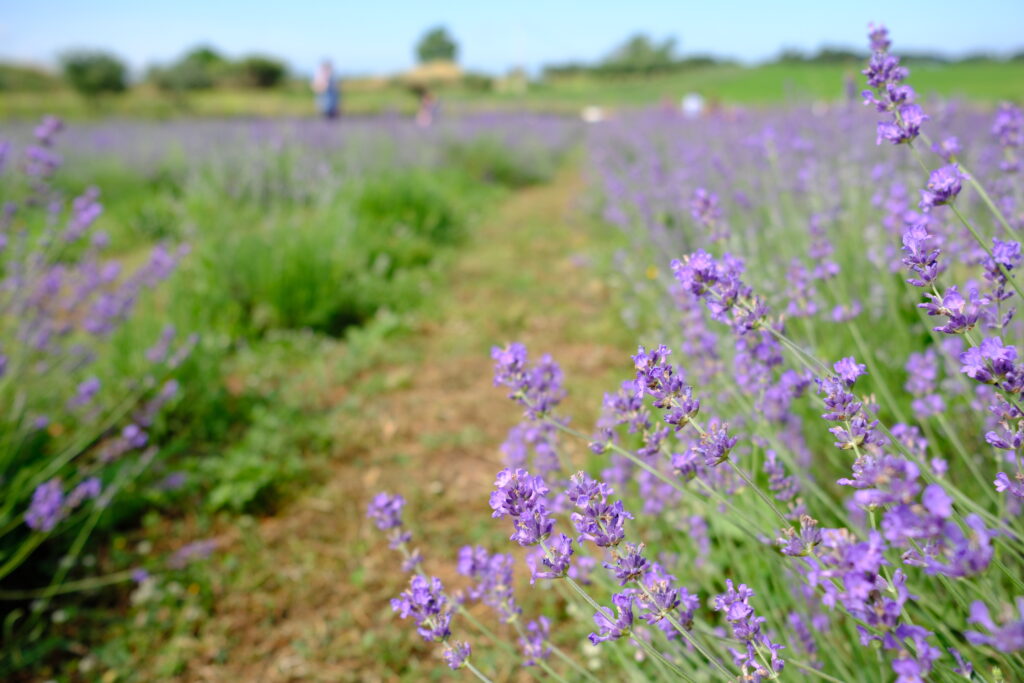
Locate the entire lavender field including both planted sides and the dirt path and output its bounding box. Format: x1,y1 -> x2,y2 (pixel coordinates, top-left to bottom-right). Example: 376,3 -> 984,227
0,15 -> 1024,683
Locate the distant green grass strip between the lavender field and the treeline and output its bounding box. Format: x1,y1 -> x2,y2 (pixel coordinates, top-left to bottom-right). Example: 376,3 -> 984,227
0,61 -> 1024,120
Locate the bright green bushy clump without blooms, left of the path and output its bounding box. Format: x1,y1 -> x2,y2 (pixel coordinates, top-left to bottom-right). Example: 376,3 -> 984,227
176,174 -> 463,337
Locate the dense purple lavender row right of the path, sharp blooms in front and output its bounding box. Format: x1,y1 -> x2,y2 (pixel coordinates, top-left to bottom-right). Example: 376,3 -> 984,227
370,24 -> 1024,683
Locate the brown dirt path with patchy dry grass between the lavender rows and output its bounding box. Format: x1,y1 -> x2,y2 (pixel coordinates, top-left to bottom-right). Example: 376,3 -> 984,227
185,162 -> 629,681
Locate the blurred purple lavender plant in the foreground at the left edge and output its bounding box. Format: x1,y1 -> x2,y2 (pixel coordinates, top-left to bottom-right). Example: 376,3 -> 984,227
0,118 -> 195,635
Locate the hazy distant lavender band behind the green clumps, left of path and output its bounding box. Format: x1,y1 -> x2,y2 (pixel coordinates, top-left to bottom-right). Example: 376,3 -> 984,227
6,113 -> 579,206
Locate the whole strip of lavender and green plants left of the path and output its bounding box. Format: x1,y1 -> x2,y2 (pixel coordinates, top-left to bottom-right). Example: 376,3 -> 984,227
0,112 -> 574,673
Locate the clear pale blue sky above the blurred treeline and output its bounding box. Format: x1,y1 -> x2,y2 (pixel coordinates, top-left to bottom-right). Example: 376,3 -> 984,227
0,0 -> 1024,73
